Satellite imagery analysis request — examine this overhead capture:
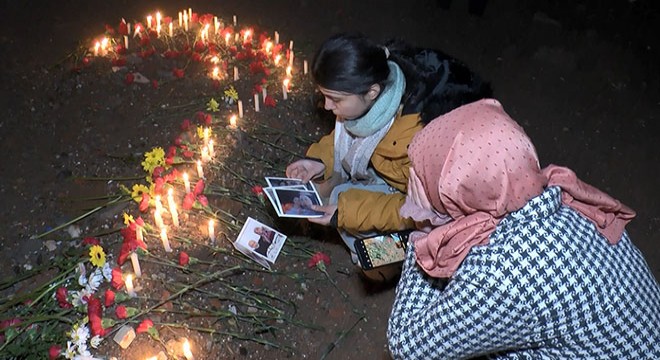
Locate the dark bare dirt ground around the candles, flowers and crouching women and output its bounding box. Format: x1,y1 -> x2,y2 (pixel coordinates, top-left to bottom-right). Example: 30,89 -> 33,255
0,0 -> 660,359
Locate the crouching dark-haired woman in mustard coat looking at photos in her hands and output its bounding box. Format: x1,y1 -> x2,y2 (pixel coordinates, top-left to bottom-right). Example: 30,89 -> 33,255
286,34 -> 491,270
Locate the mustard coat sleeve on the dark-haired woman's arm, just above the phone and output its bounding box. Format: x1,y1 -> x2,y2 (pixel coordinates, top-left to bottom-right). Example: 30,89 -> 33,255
337,189 -> 414,232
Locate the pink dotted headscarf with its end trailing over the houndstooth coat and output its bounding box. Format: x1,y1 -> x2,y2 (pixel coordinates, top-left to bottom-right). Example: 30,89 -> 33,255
401,99 -> 635,278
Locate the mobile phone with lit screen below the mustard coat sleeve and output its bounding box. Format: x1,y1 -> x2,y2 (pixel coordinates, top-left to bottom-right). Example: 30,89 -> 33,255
355,231 -> 410,270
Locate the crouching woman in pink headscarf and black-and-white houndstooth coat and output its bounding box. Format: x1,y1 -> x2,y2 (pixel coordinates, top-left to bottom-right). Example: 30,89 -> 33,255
388,99 -> 660,359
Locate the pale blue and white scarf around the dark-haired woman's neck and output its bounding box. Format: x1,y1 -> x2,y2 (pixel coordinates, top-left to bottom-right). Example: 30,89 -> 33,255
333,61 -> 406,183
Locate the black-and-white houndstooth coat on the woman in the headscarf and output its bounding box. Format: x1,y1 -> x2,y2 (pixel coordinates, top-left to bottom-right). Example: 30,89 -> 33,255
387,187 -> 660,360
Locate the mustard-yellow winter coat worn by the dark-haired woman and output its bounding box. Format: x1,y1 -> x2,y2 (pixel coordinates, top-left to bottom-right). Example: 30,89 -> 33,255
307,114 -> 423,232
